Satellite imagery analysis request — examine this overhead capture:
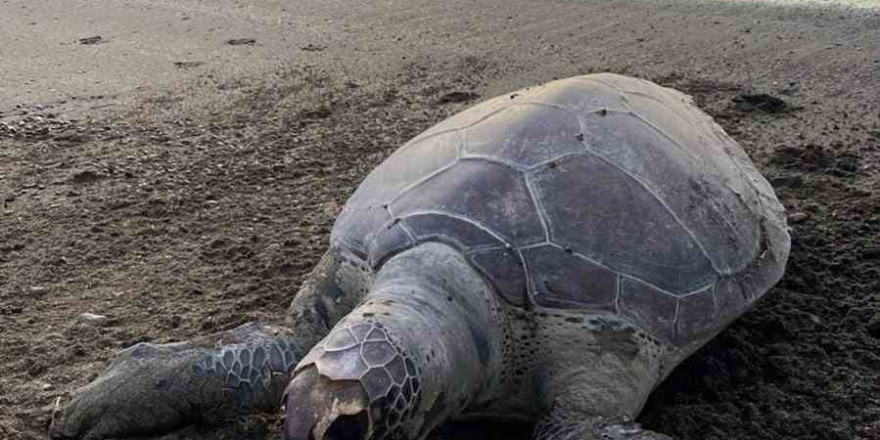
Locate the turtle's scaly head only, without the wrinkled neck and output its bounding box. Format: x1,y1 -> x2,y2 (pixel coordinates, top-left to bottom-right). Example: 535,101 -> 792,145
283,323 -> 423,440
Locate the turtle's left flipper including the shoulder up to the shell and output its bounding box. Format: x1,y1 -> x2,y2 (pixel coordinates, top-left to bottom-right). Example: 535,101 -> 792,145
49,249 -> 370,440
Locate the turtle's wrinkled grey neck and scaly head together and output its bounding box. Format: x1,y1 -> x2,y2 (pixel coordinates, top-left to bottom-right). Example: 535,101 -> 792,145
284,244 -> 503,440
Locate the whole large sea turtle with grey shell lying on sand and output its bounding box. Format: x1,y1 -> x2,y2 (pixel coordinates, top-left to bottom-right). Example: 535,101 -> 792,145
50,74 -> 790,440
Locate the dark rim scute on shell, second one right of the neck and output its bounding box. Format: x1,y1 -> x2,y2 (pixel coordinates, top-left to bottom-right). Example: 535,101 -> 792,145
523,245 -> 617,311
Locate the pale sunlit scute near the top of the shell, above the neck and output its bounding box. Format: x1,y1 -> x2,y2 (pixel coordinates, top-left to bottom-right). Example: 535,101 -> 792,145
464,104 -> 584,168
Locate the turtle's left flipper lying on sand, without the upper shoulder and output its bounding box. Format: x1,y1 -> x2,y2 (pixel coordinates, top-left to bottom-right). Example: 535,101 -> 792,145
49,323 -> 301,440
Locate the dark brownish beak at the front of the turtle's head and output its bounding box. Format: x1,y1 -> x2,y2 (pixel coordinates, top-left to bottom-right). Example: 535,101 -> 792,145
283,367 -> 372,440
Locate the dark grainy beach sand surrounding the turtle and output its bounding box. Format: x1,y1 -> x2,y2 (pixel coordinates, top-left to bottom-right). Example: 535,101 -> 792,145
0,0 -> 880,440
